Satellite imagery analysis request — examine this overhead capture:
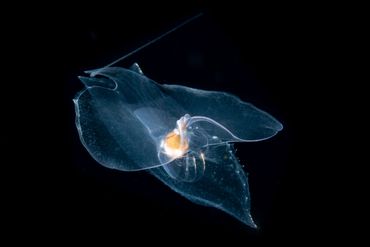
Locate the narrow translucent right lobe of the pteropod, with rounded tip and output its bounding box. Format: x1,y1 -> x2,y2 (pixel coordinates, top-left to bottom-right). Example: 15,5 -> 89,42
163,85 -> 283,141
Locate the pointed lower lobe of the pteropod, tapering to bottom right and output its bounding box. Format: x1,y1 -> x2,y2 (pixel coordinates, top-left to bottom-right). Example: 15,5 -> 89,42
148,144 -> 257,228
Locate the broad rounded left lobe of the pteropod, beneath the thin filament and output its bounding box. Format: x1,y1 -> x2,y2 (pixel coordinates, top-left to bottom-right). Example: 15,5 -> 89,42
75,68 -> 184,170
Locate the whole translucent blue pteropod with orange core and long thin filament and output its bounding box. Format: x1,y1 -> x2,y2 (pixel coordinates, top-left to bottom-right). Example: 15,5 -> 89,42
74,13 -> 283,227
